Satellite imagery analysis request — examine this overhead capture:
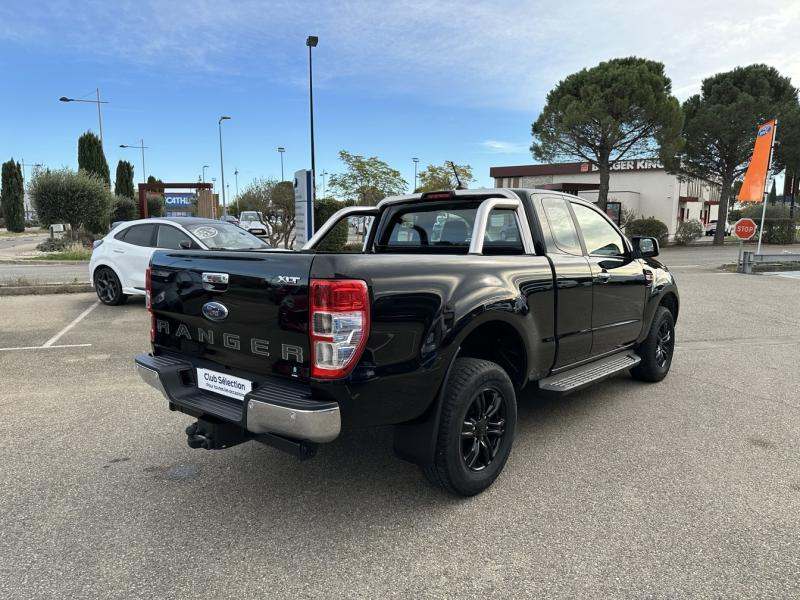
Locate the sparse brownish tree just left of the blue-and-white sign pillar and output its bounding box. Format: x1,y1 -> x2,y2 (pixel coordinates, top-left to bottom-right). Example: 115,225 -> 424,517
237,178 -> 296,248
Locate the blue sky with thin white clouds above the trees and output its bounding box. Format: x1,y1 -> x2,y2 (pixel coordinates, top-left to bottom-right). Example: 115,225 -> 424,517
0,0 -> 800,195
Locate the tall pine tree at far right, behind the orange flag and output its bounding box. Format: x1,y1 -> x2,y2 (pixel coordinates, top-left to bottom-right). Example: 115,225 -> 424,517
681,65 -> 797,244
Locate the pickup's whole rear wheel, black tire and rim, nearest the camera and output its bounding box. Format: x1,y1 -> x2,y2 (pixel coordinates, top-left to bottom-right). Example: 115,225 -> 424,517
422,358 -> 517,496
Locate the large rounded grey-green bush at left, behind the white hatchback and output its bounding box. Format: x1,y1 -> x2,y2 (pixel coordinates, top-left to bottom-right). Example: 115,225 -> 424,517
29,169 -> 112,232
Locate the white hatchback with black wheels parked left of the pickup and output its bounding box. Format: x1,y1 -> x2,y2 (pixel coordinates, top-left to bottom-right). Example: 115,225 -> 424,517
89,217 -> 269,305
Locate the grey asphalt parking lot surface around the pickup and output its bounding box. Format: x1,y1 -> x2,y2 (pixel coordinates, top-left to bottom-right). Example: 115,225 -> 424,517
0,260 -> 800,598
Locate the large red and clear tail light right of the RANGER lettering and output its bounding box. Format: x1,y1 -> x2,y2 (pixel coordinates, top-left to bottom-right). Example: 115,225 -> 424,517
309,279 -> 369,379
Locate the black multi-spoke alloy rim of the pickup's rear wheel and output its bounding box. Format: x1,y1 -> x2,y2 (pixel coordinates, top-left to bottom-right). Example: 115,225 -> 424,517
461,387 -> 506,471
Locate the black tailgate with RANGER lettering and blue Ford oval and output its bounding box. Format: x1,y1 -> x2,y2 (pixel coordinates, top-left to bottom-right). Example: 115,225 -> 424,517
151,251 -> 314,379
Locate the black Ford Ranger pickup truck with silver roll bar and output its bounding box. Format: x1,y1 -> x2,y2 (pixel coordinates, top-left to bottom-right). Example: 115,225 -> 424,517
135,189 -> 679,495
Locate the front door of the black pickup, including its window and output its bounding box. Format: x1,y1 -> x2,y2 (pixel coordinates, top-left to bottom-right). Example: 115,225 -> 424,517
570,202 -> 647,356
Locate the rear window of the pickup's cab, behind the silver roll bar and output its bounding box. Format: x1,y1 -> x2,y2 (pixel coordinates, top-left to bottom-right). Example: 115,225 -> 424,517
376,202 -> 524,254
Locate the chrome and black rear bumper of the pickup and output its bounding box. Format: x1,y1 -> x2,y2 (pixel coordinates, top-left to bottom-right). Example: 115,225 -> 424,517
134,354 -> 341,443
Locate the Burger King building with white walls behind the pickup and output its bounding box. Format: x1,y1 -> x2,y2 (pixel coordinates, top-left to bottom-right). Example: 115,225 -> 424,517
489,159 -> 720,237
